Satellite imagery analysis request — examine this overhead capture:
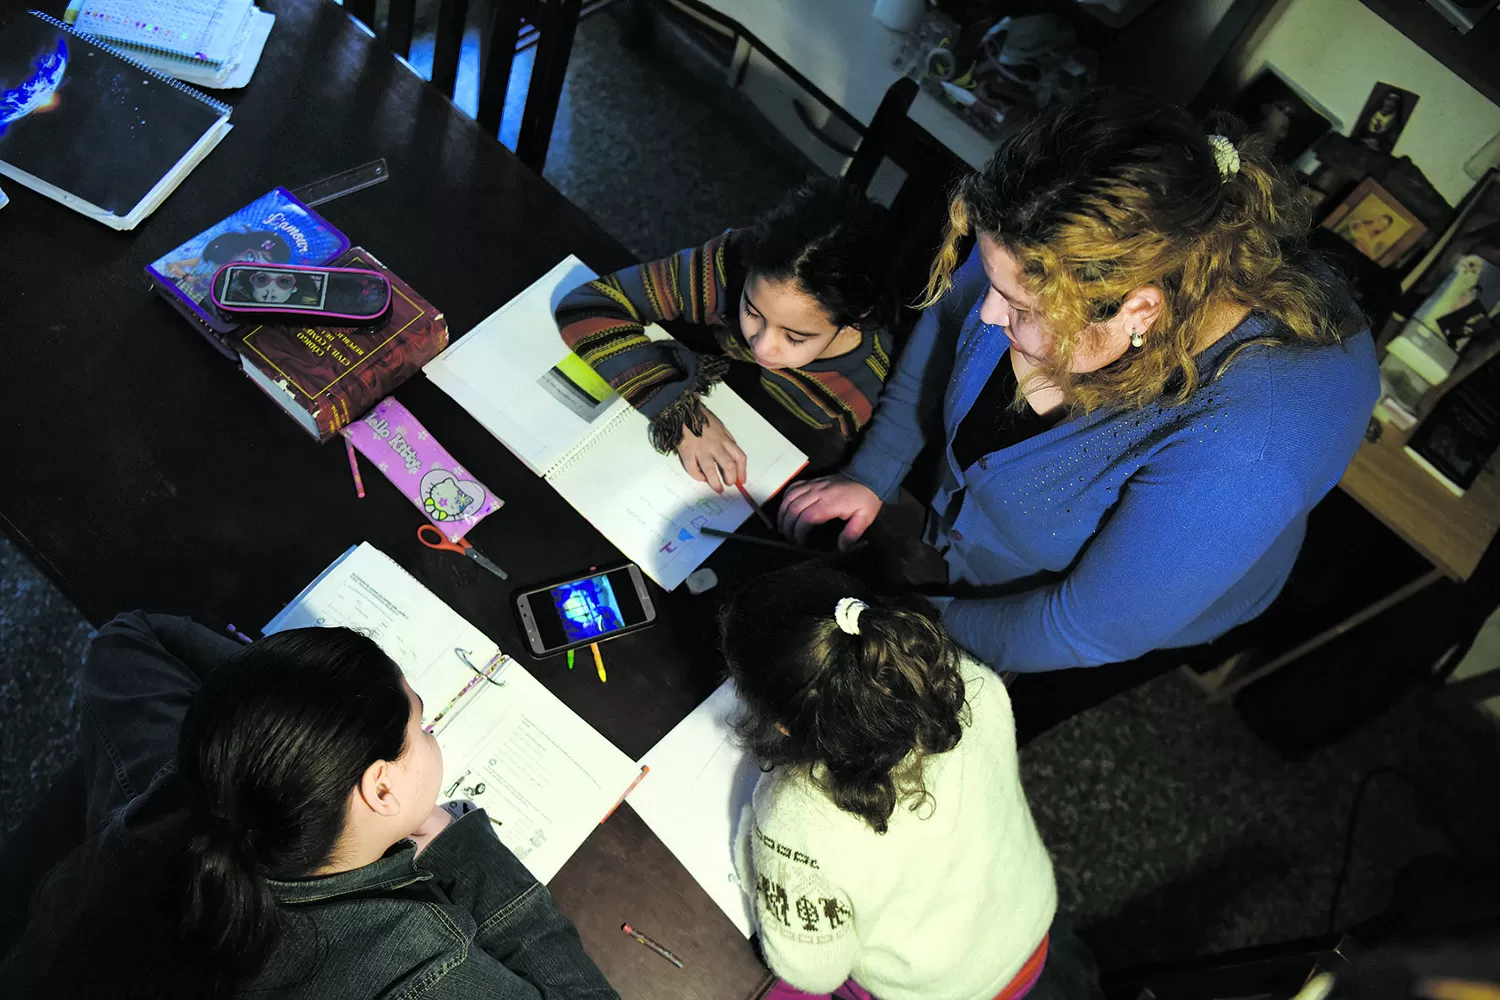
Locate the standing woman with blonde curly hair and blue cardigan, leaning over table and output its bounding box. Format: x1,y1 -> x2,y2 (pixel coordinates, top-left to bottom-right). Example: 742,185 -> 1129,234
780,91 -> 1379,741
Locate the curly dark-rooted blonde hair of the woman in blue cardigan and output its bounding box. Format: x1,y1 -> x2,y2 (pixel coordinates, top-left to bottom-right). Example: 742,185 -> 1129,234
921,90 -> 1362,412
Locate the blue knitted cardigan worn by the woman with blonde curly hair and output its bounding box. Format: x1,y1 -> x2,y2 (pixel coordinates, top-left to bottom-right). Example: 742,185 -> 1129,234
845,245 -> 1380,672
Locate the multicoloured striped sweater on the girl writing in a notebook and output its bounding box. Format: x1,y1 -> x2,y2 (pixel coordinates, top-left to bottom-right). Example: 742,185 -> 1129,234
557,229 -> 891,451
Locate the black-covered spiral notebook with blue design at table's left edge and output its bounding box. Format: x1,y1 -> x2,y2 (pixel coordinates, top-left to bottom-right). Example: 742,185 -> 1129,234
0,10 -> 230,229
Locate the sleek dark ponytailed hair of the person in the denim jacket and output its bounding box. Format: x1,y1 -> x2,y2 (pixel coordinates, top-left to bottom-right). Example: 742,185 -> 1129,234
177,628 -> 411,994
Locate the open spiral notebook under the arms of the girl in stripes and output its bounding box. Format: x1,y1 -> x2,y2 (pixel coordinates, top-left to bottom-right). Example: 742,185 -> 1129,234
423,256 -> 807,591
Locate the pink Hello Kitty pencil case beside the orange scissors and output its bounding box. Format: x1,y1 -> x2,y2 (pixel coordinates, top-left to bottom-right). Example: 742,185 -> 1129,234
339,396 -> 506,541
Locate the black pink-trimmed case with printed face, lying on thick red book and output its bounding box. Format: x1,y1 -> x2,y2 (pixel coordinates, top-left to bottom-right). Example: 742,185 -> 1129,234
209,264 -> 390,327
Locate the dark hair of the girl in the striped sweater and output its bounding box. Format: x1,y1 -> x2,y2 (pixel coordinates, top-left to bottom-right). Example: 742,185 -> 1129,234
738,177 -> 899,330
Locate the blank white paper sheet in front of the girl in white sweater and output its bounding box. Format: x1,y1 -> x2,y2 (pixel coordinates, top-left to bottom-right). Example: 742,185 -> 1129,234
629,681 -> 761,937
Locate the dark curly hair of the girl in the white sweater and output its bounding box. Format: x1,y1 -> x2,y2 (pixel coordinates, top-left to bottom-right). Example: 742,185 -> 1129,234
720,565 -> 965,834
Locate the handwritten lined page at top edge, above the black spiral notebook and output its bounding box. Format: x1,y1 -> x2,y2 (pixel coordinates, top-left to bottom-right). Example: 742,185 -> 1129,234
75,0 -> 251,64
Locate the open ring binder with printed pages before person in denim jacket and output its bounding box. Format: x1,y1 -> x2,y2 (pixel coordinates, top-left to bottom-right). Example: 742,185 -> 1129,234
264,543 -> 650,883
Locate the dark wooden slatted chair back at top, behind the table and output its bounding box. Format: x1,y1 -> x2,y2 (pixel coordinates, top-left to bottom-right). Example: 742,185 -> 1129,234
344,0 -> 584,174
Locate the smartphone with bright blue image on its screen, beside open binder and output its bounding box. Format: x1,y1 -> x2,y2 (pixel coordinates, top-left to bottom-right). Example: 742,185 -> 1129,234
516,564 -> 656,657
